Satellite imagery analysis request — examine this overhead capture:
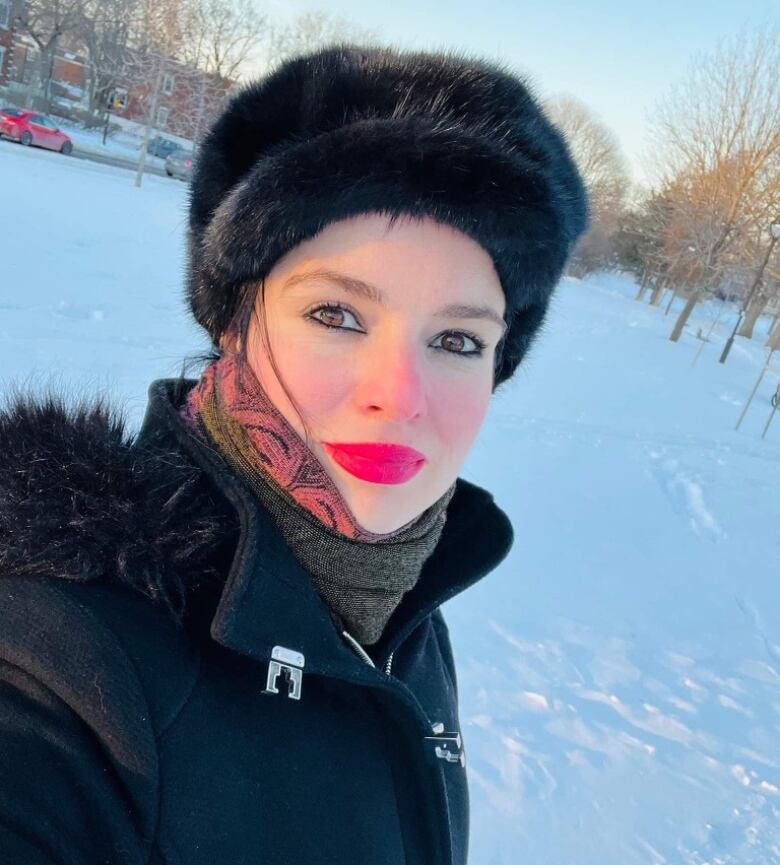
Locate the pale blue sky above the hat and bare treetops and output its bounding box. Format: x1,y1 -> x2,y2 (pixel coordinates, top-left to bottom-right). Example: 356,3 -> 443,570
264,0 -> 780,191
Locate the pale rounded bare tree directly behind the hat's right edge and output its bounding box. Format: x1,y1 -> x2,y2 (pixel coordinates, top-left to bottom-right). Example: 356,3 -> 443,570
545,96 -> 630,276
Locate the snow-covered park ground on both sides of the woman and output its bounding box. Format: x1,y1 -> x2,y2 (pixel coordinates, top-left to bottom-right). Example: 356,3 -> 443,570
0,142 -> 780,865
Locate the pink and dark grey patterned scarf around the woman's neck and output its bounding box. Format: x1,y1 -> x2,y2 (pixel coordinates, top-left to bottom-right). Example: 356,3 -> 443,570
182,355 -> 455,645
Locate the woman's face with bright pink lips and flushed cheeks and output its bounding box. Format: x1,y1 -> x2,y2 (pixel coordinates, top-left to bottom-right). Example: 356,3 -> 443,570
247,214 -> 505,534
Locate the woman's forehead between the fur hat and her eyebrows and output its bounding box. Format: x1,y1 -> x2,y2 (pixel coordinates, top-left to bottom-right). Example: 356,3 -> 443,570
268,214 -> 505,316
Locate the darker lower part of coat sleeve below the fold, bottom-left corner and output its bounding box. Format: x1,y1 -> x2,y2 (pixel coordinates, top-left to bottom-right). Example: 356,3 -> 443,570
0,662 -> 155,865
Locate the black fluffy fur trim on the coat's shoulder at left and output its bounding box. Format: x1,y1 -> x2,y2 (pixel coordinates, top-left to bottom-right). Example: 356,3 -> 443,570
0,395 -> 232,617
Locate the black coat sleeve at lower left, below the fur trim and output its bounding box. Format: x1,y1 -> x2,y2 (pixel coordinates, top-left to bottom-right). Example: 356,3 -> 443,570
0,576 -> 158,865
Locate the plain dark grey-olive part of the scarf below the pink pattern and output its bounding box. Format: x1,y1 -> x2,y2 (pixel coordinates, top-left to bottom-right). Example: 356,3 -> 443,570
190,403 -> 455,645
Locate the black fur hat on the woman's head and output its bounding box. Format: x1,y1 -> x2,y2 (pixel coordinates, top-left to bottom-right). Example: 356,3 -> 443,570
187,45 -> 587,387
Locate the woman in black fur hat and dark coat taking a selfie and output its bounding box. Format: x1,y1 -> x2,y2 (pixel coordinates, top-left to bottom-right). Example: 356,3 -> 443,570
0,46 -> 586,865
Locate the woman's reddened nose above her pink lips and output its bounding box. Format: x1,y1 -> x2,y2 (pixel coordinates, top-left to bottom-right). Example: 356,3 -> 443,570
355,334 -> 425,423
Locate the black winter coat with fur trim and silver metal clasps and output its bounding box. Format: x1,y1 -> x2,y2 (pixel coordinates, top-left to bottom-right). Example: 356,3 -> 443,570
0,380 -> 512,865
